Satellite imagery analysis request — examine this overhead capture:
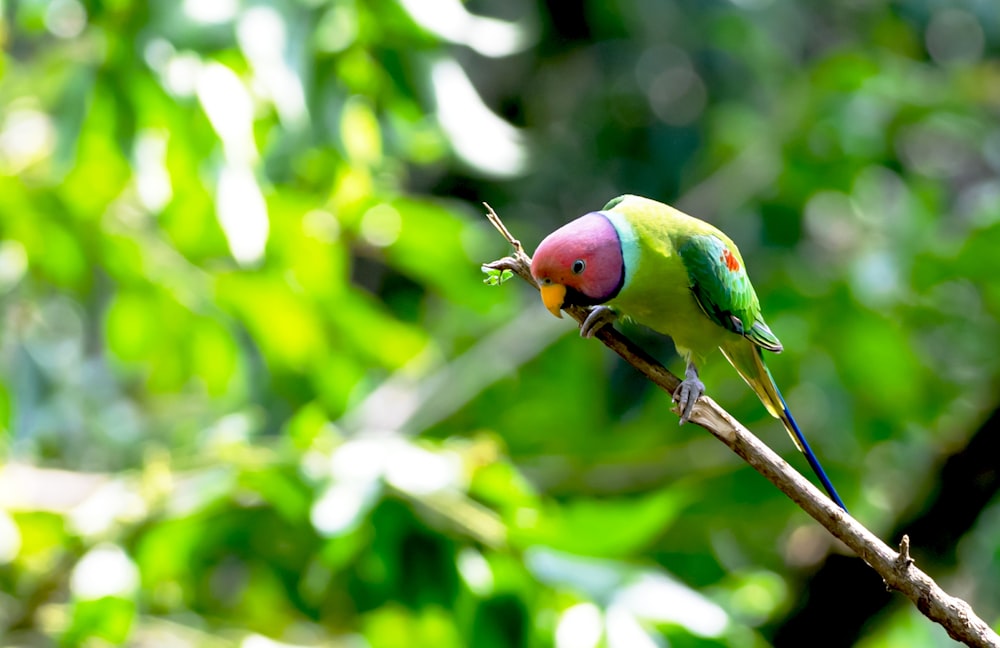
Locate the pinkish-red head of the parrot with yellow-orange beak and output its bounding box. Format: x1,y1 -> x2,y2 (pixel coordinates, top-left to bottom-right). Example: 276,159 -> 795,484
531,212 -> 625,317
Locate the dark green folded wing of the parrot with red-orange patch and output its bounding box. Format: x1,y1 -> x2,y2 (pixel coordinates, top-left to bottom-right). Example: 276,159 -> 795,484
677,234 -> 782,352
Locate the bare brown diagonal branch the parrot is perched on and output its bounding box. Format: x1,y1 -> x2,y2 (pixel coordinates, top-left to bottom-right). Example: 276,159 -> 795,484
483,203 -> 1000,648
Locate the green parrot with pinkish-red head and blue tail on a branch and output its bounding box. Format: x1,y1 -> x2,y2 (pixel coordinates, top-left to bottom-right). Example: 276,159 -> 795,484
531,195 -> 847,511
